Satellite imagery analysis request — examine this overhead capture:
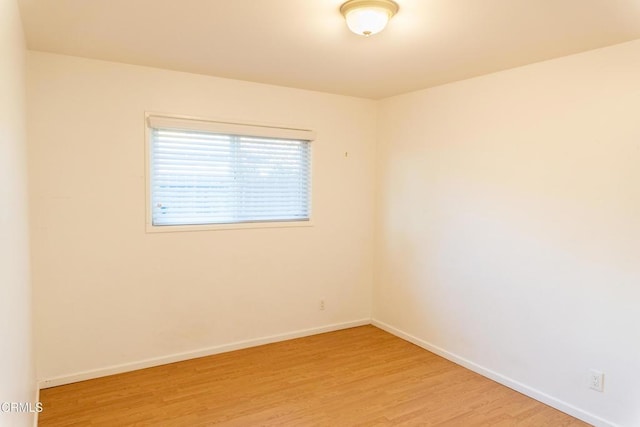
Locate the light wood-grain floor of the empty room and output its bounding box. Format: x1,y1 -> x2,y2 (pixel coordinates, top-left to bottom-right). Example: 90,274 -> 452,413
39,326 -> 587,427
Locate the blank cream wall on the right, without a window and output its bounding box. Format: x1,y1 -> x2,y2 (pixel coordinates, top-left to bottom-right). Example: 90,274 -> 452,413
373,41 -> 640,426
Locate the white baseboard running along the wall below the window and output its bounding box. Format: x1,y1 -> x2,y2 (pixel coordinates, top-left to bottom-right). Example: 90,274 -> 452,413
38,319 -> 371,389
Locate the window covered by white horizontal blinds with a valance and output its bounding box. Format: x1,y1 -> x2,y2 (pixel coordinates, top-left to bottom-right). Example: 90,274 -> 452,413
148,116 -> 313,228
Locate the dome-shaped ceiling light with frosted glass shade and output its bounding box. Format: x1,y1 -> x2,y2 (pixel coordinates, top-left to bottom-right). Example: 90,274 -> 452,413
340,0 -> 399,37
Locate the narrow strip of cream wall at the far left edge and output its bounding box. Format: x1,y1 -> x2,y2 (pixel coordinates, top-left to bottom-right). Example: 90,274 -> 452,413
0,0 -> 36,426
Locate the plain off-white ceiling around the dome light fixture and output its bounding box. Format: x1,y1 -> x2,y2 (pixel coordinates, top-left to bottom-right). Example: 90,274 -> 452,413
20,0 -> 640,99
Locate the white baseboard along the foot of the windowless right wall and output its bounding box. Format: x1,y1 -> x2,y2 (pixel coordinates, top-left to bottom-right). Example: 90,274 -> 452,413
371,319 -> 620,427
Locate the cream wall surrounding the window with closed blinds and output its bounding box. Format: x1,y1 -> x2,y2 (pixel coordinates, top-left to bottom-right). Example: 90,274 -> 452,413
28,52 -> 376,385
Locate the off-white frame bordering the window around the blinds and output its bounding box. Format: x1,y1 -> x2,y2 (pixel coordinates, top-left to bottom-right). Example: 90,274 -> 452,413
144,112 -> 315,233
